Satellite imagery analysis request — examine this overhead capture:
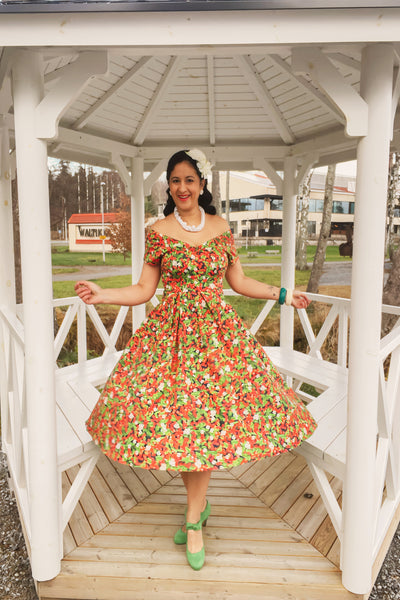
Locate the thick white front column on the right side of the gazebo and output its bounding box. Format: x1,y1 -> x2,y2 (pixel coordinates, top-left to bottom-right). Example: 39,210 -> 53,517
342,44 -> 393,594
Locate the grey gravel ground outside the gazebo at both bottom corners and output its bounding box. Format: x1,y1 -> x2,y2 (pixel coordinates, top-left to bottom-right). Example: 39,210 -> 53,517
0,442 -> 400,600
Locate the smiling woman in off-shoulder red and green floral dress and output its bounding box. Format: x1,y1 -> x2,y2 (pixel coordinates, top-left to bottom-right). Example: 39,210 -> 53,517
75,149 -> 316,570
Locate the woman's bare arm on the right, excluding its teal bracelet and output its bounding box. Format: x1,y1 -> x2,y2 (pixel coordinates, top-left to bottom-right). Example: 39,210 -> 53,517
225,260 -> 311,308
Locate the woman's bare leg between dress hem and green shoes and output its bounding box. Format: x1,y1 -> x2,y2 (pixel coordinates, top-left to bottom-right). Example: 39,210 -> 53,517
181,471 -> 211,552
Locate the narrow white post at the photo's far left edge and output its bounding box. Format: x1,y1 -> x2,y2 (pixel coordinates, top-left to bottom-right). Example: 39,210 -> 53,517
0,117 -> 15,310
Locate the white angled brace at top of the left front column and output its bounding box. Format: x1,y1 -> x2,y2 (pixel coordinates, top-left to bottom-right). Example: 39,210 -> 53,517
35,52 -> 108,139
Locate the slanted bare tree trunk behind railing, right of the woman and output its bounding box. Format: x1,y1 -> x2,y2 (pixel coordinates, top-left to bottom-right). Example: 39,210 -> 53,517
307,165 -> 336,294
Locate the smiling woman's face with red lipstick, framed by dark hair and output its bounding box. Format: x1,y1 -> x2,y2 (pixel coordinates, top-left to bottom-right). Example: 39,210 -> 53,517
168,161 -> 204,212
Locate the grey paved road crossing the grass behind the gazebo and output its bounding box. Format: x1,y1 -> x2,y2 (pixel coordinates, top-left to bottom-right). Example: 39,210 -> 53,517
53,262 -> 351,285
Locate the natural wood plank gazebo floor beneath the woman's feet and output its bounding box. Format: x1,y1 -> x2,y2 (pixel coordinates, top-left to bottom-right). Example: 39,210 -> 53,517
38,453 -> 361,600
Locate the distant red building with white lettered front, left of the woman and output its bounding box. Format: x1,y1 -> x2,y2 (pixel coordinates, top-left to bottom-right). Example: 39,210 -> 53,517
68,213 -> 118,252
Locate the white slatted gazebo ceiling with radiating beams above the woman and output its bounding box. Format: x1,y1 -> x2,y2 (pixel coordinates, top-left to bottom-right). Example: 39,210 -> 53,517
32,44 -> 368,169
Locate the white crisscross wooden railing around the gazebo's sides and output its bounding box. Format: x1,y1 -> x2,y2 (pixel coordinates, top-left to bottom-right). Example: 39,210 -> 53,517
0,289 -> 400,580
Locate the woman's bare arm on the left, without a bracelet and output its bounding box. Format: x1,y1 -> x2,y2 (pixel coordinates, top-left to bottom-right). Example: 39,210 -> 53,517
75,263 -> 161,306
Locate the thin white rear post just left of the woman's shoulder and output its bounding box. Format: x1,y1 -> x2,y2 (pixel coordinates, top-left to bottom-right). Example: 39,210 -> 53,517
131,157 -> 146,332
